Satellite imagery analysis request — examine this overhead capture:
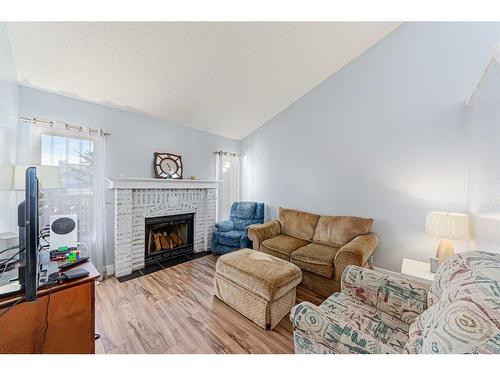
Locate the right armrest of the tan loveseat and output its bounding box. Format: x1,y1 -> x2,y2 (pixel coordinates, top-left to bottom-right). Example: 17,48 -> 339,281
334,233 -> 378,281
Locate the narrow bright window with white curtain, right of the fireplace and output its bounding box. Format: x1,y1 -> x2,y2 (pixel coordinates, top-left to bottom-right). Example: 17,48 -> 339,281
215,151 -> 240,221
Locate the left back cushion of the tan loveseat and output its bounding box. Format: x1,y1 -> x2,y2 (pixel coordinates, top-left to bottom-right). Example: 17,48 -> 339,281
279,207 -> 319,241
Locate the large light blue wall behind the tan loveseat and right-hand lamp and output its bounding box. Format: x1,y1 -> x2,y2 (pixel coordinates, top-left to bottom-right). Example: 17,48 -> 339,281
242,23 -> 500,270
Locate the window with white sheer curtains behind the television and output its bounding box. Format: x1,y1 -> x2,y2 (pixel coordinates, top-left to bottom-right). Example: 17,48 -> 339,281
18,123 -> 106,276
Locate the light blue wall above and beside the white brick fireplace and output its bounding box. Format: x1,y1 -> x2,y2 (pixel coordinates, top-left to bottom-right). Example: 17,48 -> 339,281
19,86 -> 240,265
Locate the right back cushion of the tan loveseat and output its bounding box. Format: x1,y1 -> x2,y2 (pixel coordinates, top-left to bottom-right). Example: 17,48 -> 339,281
313,216 -> 373,247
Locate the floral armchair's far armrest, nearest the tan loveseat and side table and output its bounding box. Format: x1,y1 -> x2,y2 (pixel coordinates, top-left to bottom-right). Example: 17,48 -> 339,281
341,266 -> 427,324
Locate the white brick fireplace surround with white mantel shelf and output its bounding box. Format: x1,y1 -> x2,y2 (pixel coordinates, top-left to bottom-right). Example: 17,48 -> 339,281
107,178 -> 218,277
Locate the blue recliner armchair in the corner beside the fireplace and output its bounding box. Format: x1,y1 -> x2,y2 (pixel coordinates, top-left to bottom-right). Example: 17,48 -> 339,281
212,202 -> 264,254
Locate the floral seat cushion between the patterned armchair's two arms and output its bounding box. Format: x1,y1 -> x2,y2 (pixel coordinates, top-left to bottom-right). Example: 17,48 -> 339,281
320,293 -> 409,353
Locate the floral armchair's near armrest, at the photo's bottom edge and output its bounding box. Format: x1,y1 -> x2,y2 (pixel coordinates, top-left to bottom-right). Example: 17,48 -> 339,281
290,302 -> 396,354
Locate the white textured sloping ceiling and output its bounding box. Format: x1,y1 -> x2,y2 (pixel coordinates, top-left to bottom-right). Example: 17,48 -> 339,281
8,22 -> 400,139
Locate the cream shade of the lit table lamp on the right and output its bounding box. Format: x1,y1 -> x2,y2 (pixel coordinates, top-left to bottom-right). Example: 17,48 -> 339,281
425,211 -> 471,240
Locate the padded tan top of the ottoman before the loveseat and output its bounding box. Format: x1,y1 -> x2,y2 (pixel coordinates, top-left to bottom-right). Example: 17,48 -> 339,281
215,249 -> 302,302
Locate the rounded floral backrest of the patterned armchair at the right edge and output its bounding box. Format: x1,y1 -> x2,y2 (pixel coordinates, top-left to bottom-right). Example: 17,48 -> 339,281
406,252 -> 500,353
